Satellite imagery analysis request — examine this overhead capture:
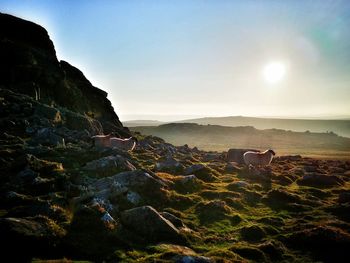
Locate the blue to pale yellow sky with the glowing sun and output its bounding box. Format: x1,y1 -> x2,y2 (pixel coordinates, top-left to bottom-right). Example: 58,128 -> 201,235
0,0 -> 350,121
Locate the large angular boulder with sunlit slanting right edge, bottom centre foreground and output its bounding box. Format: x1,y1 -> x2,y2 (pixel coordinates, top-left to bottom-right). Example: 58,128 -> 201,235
120,206 -> 181,242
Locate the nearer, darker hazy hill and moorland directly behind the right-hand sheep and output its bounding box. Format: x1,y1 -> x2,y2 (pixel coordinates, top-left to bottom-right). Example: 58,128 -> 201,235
131,123 -> 350,156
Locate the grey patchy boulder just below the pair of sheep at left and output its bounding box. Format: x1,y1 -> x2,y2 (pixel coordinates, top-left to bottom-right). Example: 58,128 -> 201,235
82,155 -> 136,177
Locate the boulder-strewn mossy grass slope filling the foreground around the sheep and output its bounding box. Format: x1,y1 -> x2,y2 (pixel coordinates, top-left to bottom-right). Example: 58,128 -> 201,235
0,89 -> 350,262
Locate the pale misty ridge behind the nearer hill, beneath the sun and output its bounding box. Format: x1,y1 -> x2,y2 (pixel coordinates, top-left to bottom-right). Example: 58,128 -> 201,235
174,116 -> 350,137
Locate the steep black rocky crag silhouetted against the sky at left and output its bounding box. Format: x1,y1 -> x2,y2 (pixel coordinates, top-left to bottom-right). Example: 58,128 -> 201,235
0,13 -> 129,136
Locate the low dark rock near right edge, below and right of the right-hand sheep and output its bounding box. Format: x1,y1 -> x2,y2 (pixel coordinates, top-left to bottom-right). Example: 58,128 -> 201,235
297,173 -> 344,187
